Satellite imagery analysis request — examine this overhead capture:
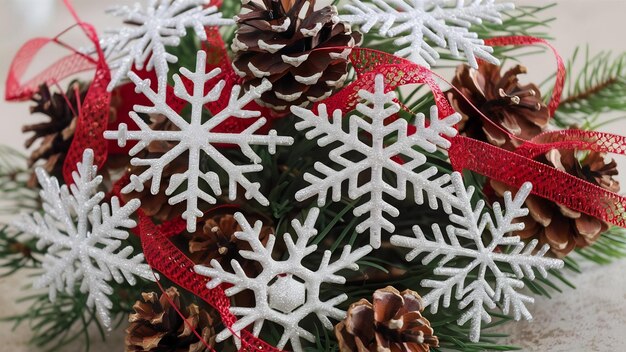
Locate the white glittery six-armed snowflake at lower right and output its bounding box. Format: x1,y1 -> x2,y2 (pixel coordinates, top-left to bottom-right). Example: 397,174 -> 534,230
391,172 -> 563,341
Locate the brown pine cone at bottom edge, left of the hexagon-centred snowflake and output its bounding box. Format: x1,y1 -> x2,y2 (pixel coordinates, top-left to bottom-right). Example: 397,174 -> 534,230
126,287 -> 215,352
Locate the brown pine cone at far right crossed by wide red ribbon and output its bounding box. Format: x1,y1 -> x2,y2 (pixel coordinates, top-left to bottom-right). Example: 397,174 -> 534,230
491,149 -> 620,258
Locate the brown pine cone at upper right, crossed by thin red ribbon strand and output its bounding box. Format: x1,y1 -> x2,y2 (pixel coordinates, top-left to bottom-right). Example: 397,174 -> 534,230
446,63 -> 549,150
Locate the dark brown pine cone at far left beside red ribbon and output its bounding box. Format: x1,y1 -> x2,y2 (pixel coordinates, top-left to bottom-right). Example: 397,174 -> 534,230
22,82 -> 89,187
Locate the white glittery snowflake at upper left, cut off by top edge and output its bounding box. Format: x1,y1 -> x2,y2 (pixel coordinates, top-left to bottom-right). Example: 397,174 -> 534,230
101,0 -> 234,90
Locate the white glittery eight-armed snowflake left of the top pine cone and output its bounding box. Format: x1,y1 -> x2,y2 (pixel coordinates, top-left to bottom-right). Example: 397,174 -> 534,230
104,51 -> 293,232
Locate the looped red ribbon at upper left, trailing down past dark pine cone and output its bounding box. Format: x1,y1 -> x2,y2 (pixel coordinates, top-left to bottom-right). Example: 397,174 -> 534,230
5,0 -> 111,184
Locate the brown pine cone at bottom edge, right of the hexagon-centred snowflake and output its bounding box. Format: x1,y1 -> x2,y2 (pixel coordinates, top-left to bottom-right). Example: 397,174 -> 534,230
335,286 -> 439,352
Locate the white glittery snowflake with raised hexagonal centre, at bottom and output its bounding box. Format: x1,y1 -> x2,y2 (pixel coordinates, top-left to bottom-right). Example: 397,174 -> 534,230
195,208 -> 372,351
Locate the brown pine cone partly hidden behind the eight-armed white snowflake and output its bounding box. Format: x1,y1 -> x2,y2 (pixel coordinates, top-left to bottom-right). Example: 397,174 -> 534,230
122,115 -> 188,221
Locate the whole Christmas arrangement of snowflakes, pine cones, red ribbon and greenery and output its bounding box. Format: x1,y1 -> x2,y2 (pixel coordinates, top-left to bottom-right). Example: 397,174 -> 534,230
0,0 -> 626,352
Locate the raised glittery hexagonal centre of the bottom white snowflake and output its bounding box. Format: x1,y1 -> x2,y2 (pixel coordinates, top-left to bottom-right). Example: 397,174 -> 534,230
267,274 -> 306,313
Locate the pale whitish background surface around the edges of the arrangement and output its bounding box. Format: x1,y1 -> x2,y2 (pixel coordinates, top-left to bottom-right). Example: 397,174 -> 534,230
0,0 -> 626,352
